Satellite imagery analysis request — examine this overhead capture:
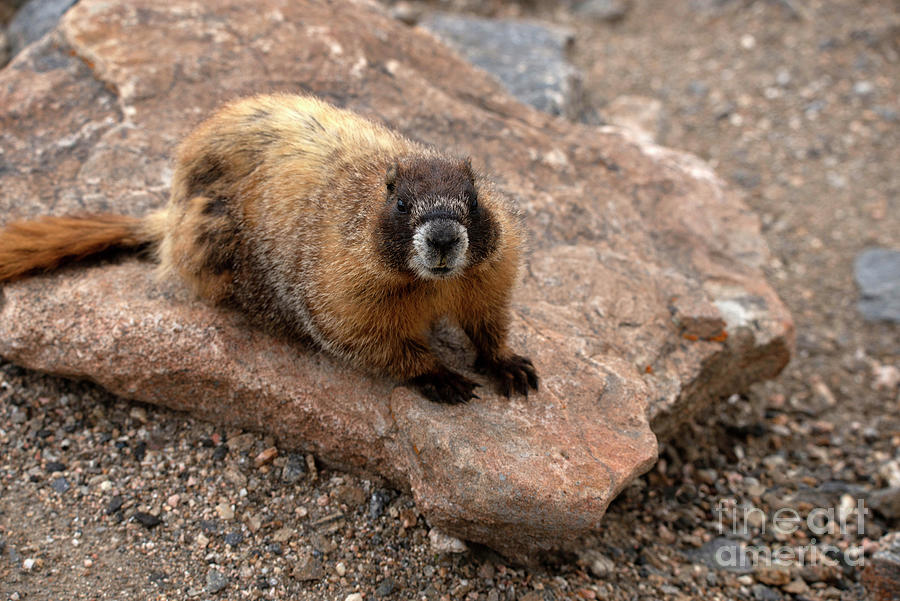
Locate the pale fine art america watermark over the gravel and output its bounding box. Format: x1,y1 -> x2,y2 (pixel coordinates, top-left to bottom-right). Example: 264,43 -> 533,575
714,497 -> 869,571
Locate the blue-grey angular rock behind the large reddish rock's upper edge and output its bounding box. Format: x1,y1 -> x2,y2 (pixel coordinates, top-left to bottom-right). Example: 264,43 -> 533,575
420,13 -> 583,118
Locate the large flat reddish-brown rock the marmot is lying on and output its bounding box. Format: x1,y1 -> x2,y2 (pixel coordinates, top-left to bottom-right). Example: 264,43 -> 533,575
0,0 -> 793,560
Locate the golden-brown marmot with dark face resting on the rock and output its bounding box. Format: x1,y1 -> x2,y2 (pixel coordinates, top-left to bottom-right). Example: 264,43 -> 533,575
0,94 -> 538,403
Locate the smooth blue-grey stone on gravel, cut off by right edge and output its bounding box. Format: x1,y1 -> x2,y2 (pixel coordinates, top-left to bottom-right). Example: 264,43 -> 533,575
853,248 -> 900,323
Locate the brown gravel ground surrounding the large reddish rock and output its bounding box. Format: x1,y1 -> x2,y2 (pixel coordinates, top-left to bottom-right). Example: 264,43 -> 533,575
0,0 -> 900,601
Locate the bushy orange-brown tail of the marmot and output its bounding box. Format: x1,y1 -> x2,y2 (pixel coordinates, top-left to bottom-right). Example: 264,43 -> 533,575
0,212 -> 164,282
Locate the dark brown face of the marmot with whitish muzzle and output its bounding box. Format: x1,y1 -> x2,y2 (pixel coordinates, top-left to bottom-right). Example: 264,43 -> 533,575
378,157 -> 497,280
